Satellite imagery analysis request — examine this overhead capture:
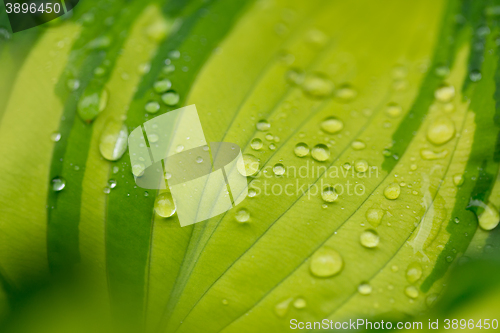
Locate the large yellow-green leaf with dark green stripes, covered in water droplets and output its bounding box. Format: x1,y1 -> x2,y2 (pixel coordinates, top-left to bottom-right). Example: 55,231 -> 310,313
0,0 -> 500,332
